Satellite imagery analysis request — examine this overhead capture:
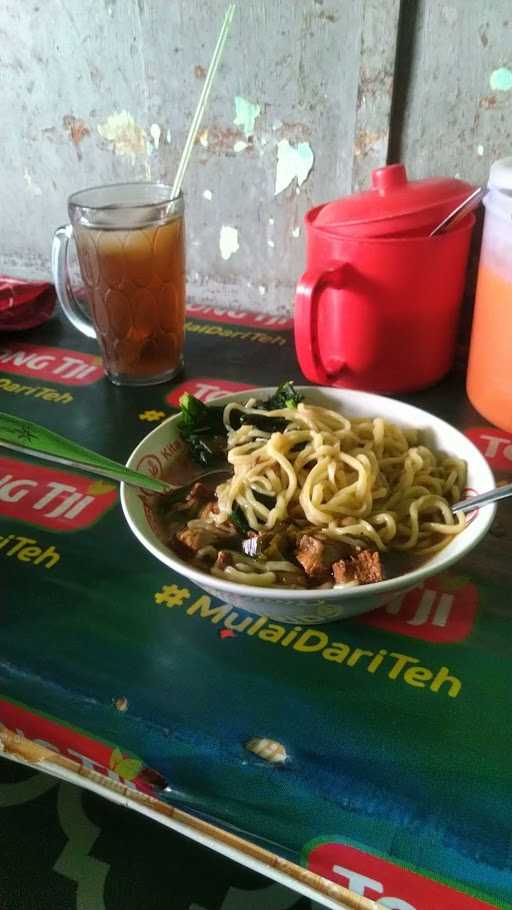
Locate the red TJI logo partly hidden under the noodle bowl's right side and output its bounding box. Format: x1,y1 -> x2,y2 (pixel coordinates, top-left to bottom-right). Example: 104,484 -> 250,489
356,572 -> 479,644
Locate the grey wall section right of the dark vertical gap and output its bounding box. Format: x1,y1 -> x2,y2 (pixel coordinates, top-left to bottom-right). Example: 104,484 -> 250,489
394,0 -> 512,183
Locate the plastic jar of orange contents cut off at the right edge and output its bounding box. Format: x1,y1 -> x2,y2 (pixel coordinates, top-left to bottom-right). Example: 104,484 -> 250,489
467,158 -> 512,432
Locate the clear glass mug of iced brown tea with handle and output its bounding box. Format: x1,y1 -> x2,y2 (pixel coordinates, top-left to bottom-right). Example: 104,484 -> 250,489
52,183 -> 185,385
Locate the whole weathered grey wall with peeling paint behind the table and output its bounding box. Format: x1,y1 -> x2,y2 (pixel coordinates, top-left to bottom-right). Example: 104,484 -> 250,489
0,0 -> 512,312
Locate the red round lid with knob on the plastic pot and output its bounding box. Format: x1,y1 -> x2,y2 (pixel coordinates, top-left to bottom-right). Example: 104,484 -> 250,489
314,164 -> 474,235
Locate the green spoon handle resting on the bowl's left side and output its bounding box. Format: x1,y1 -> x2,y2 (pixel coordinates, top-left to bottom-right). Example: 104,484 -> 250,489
0,411 -> 169,493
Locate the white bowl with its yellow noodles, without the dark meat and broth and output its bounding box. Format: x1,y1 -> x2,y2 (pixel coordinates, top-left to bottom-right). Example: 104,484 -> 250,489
121,387 -> 495,623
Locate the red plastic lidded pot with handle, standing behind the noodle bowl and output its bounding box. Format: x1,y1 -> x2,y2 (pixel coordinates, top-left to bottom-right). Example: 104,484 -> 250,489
295,164 -> 475,393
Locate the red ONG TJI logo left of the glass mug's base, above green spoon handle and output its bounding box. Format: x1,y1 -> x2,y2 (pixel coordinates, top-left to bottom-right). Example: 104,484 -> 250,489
0,342 -> 105,385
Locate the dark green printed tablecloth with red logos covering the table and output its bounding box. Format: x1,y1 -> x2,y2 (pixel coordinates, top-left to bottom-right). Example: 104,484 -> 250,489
0,309 -> 512,910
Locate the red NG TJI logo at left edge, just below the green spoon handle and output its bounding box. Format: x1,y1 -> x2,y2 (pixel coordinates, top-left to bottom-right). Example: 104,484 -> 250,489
0,458 -> 117,531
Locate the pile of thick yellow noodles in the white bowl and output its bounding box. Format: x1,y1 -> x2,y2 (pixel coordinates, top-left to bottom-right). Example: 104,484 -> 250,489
190,399 -> 466,587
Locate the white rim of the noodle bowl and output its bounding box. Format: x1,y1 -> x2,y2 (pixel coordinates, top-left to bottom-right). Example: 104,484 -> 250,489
120,385 -> 497,601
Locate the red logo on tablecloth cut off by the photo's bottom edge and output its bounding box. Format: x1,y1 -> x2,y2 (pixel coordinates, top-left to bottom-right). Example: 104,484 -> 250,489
303,839 -> 493,910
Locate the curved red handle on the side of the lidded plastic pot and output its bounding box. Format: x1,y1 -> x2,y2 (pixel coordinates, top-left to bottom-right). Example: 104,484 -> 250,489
295,262 -> 347,385
